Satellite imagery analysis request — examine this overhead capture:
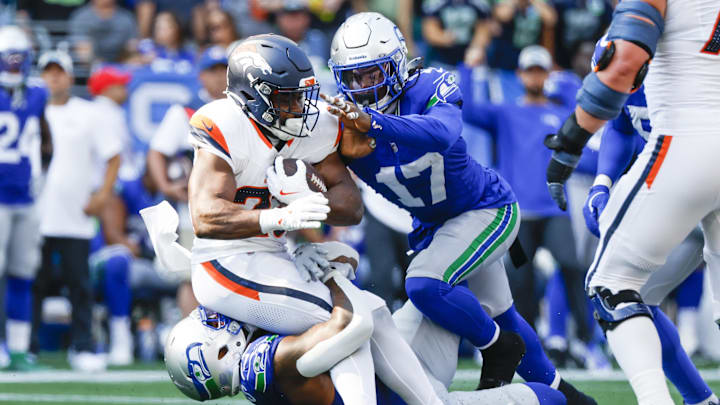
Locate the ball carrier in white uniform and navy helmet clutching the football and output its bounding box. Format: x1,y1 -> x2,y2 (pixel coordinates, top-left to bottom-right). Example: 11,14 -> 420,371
188,35 -> 394,405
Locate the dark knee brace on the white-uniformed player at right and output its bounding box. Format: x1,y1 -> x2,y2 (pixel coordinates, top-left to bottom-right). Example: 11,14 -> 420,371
590,288 -> 652,332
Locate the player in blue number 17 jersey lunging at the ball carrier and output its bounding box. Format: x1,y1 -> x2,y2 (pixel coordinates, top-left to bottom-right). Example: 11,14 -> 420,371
324,13 -> 595,404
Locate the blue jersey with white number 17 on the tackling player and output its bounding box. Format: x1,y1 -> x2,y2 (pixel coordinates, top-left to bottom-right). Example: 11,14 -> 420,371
350,69 -> 515,250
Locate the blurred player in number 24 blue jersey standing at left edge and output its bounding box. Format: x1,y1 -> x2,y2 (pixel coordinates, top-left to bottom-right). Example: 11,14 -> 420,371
0,26 -> 52,371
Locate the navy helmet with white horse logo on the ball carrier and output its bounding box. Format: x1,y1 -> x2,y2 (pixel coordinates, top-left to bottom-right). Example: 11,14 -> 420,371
226,34 -> 320,140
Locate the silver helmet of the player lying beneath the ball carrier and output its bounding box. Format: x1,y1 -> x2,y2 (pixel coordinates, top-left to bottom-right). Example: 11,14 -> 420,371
165,306 -> 247,401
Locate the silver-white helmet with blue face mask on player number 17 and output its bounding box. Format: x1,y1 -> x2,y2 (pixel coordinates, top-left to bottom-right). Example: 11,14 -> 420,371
328,12 -> 408,111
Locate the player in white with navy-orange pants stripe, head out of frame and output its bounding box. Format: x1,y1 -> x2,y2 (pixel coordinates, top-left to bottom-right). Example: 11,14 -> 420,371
546,0 -> 720,405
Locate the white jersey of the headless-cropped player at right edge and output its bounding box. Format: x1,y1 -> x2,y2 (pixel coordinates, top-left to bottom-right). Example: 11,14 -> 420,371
645,0 -> 720,136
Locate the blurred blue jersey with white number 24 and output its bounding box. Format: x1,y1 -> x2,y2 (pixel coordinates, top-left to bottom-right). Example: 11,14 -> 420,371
0,86 -> 47,204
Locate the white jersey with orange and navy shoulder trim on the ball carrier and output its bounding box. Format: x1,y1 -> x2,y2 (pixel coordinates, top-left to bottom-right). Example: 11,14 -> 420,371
190,99 -> 340,263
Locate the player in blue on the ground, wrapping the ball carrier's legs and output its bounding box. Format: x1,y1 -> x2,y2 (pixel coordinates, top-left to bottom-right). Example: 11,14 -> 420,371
165,242 -> 566,405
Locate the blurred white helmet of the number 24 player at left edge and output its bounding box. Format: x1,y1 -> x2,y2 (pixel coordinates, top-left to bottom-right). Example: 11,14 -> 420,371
0,25 -> 32,88
